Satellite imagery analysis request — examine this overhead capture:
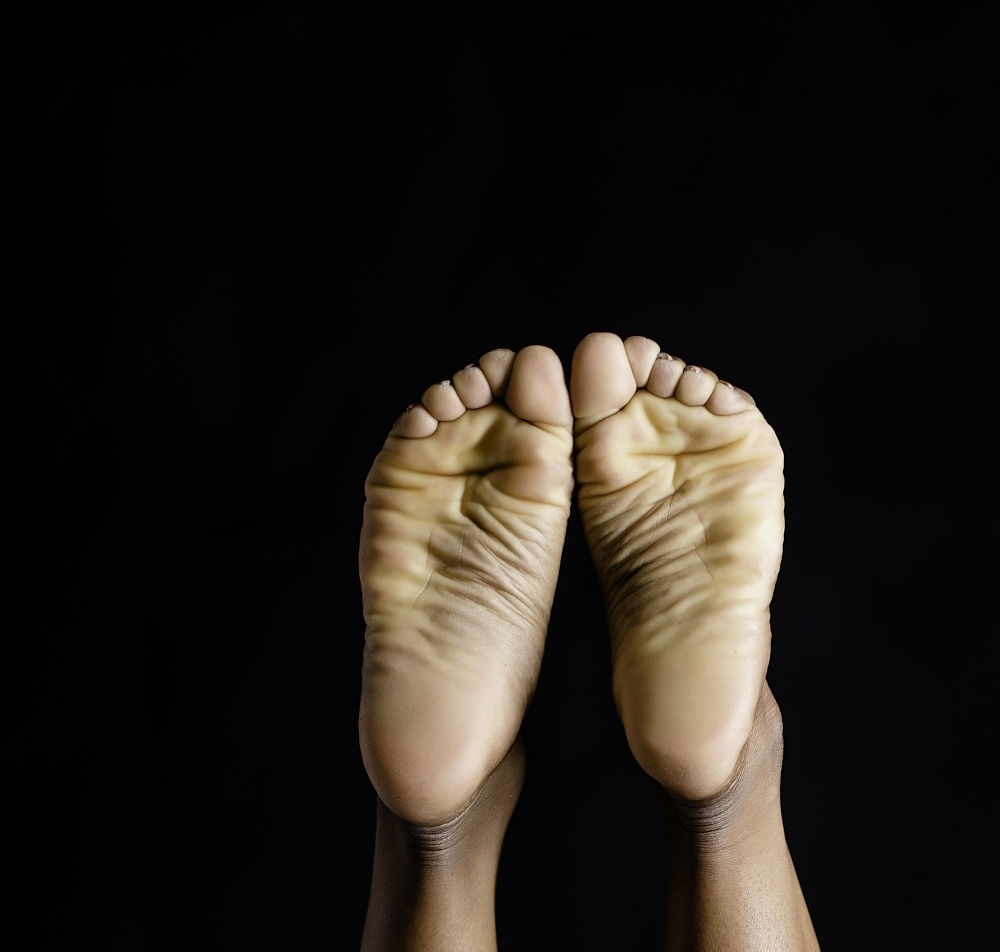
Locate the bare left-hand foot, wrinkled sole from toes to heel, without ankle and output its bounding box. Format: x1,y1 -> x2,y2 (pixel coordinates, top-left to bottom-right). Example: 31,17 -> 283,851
359,345 -> 573,824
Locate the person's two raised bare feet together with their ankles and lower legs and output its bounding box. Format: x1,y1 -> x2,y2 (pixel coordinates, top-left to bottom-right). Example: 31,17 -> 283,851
359,333 -> 818,952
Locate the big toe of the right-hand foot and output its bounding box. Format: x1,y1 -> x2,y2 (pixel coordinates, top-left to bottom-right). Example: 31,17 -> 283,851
570,331 -> 637,427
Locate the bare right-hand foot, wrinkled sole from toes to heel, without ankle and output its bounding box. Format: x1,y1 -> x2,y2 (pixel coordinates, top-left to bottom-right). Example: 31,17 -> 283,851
570,333 -> 784,800
